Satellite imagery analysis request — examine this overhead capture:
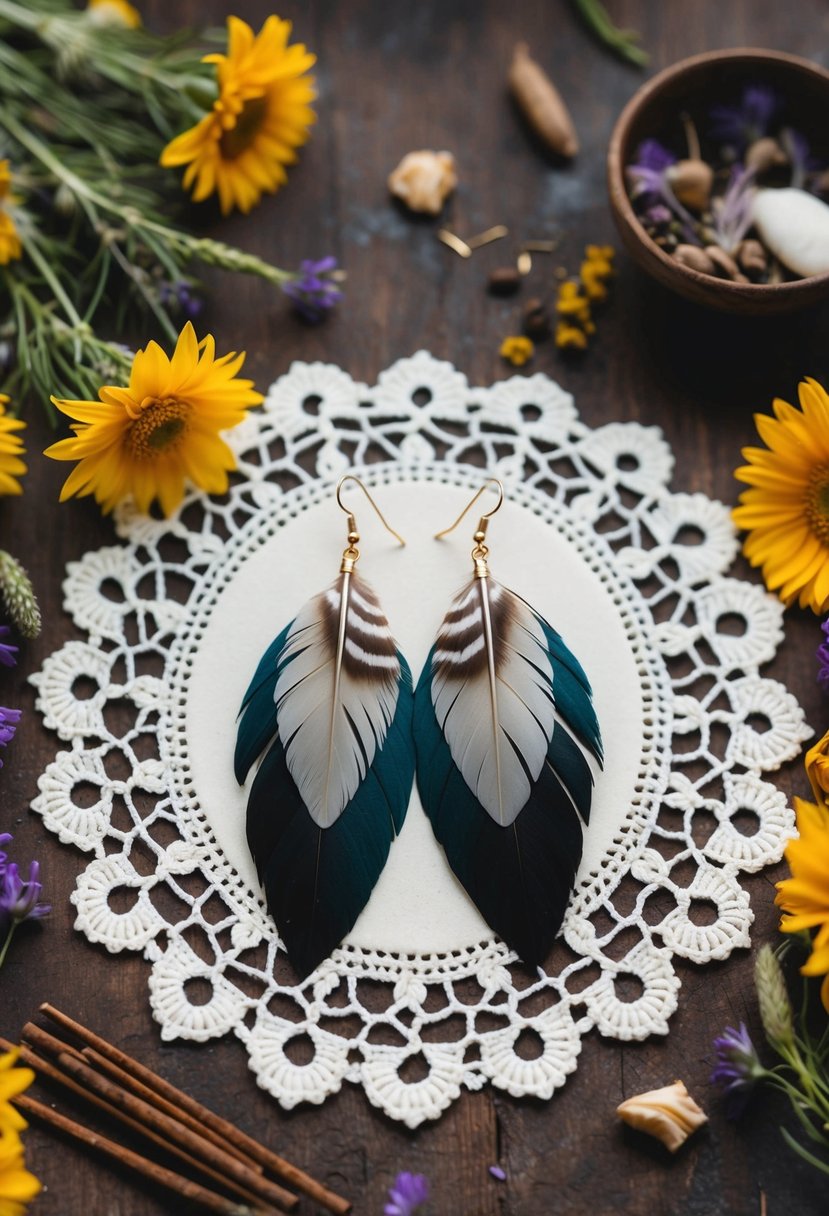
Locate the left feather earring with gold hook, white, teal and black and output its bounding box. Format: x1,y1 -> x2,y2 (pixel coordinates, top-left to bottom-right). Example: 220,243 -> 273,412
235,473 -> 415,976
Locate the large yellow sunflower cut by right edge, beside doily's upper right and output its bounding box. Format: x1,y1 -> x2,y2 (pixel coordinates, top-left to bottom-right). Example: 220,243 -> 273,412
733,379 -> 829,613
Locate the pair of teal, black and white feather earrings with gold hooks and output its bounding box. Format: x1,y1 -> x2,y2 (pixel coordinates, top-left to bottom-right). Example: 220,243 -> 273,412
235,474 -> 602,976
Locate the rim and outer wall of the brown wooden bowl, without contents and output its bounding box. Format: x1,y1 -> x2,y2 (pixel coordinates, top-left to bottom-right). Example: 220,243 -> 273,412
608,47 -> 829,316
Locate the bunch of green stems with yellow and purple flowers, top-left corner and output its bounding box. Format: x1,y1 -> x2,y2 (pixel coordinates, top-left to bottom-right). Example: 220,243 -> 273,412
0,0 -> 339,402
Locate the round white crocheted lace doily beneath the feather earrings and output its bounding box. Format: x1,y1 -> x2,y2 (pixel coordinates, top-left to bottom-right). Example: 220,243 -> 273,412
32,351 -> 810,1127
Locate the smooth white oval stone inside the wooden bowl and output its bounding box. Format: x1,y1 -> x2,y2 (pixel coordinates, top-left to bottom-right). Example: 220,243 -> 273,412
754,186 -> 829,277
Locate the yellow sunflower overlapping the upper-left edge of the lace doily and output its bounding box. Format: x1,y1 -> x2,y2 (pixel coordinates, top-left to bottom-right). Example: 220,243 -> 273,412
46,321 -> 263,516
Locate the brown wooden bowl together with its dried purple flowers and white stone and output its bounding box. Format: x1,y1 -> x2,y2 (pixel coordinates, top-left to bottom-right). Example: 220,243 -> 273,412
608,50 -> 829,314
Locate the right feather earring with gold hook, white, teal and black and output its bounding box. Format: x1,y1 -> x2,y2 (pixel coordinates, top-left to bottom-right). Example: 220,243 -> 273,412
415,478 -> 602,966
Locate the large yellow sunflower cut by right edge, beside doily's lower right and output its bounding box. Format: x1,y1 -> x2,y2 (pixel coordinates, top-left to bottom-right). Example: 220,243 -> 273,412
774,798 -> 829,1013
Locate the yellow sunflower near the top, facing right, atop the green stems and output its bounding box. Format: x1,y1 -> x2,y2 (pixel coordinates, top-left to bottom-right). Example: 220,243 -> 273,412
162,17 -> 316,215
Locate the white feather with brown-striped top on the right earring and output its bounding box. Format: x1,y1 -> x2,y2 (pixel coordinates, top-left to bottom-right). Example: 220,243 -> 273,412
432,579 -> 556,827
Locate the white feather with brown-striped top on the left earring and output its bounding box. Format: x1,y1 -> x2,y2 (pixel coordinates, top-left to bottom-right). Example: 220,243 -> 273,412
273,575 -> 400,828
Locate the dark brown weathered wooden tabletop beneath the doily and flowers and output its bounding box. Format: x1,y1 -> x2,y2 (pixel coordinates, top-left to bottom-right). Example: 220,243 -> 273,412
0,0 -> 829,1216
